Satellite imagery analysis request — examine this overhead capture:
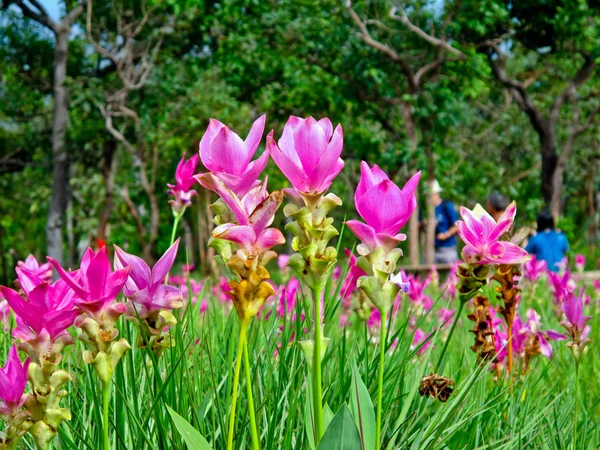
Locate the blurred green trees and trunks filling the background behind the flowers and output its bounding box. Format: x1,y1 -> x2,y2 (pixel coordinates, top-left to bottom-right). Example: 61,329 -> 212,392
0,0 -> 600,284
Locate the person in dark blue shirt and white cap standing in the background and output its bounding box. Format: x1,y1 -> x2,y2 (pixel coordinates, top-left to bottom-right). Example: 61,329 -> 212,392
429,180 -> 458,264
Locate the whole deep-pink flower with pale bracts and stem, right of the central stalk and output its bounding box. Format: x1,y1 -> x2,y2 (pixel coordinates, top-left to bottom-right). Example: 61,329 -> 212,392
346,161 -> 421,448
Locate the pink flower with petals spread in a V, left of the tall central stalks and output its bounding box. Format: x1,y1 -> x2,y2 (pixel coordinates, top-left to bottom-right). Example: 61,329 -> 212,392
115,239 -> 183,319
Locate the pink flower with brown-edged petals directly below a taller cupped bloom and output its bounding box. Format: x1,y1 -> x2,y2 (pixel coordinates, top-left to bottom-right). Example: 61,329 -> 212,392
197,173 -> 285,254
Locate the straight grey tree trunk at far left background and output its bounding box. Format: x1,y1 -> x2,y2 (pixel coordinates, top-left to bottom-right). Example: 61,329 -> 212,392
46,27 -> 71,264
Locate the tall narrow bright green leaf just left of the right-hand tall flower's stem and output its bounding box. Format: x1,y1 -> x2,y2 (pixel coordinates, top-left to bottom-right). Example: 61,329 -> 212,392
350,364 -> 377,450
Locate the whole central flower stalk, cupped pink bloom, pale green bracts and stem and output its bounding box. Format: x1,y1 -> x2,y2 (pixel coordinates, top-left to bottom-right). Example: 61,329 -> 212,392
267,116 -> 344,443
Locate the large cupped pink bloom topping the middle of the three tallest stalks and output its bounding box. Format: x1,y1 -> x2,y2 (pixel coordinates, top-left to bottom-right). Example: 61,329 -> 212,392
267,116 -> 344,195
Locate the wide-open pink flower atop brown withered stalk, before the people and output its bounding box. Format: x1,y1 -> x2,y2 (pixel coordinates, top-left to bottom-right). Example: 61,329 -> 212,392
456,202 -> 529,264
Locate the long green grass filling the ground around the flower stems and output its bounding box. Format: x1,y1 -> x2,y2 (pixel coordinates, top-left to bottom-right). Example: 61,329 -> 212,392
0,264 -> 600,450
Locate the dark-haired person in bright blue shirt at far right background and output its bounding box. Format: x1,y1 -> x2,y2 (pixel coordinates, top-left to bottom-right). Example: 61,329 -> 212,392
525,210 -> 569,272
